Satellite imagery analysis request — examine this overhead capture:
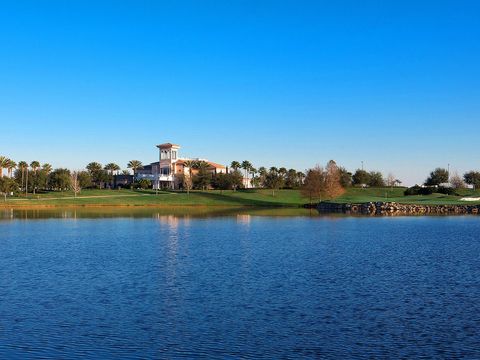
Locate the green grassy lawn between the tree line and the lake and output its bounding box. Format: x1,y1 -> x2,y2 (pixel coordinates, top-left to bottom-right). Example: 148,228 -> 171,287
0,188 -> 480,207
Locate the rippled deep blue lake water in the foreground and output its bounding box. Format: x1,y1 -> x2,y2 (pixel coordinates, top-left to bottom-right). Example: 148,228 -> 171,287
0,210 -> 480,359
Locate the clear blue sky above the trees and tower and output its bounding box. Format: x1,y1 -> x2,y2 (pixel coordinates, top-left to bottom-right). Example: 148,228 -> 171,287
0,0 -> 480,184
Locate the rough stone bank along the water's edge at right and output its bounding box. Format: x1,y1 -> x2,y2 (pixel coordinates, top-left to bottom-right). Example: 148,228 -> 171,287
316,202 -> 480,216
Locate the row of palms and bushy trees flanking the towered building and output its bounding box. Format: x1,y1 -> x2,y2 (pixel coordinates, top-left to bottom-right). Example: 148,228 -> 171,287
0,156 -> 480,199
